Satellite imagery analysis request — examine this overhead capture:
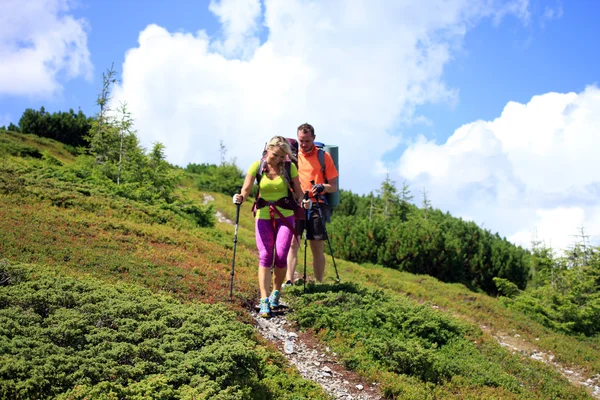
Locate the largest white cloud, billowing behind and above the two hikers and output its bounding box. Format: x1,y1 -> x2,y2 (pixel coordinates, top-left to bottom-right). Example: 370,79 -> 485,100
114,0 -> 527,192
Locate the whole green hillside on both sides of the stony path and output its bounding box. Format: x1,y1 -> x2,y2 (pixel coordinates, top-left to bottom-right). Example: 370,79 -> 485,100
0,132 -> 600,399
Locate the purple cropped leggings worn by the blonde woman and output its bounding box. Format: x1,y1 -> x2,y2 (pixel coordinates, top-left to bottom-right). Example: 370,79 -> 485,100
256,215 -> 294,268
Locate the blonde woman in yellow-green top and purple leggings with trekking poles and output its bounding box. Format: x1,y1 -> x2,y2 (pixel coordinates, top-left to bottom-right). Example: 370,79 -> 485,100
233,136 -> 312,317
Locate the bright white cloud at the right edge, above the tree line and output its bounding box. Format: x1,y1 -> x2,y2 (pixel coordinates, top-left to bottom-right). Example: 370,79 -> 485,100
398,86 -> 600,248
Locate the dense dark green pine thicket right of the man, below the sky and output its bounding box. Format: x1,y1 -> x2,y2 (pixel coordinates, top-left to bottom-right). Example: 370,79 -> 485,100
328,177 -> 529,294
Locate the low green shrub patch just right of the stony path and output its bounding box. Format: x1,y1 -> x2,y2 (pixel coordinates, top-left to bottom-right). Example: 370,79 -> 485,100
292,284 -> 519,394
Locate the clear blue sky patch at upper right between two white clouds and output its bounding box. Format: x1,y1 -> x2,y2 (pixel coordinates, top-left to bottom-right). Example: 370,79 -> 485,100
392,0 -> 600,158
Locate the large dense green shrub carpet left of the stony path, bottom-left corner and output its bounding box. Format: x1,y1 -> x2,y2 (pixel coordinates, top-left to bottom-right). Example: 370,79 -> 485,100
0,264 -> 322,399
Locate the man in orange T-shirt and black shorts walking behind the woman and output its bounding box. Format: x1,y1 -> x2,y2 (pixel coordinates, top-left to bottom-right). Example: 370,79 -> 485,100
286,124 -> 339,285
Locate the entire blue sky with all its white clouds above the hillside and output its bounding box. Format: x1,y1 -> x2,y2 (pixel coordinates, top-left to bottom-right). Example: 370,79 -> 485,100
0,0 -> 600,247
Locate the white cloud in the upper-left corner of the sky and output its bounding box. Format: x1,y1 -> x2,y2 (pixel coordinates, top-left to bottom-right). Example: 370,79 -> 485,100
0,0 -> 92,96
